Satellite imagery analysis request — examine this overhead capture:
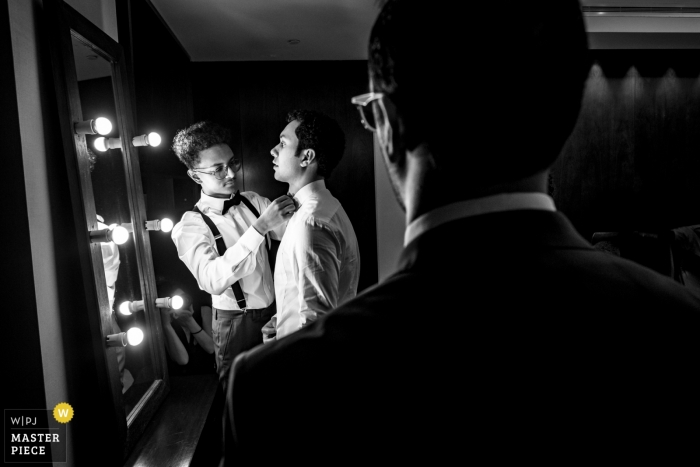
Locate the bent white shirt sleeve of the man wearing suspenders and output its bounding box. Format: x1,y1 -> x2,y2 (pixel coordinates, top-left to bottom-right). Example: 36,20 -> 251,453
172,213 -> 265,295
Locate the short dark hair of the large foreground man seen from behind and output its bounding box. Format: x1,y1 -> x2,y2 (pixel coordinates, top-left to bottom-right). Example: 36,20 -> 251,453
368,0 -> 590,186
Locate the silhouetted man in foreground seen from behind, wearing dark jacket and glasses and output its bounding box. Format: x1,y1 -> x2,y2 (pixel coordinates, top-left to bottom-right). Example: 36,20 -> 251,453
225,0 -> 700,465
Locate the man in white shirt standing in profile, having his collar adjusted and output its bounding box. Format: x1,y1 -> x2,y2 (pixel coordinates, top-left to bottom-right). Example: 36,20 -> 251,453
263,110 -> 360,343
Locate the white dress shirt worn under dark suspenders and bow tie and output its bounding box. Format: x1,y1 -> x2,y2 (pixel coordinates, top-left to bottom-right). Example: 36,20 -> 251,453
172,191 -> 284,310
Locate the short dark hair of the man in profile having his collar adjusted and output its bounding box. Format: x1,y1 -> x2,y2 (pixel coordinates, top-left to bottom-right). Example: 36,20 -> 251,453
287,110 -> 345,177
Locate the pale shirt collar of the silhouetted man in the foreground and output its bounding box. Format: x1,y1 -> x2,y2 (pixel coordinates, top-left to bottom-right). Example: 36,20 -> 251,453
403,193 -> 556,246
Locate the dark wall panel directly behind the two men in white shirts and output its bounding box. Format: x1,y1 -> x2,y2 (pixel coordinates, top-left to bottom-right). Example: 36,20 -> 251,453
191,61 -> 377,289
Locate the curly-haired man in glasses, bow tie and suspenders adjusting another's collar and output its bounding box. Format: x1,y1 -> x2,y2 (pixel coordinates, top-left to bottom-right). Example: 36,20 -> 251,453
172,122 -> 295,383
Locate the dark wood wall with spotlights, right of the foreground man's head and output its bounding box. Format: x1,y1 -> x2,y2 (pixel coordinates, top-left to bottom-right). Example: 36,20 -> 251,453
552,50 -> 700,239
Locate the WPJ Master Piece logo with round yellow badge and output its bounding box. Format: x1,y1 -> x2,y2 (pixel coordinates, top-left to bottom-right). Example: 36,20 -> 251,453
5,404 -> 67,463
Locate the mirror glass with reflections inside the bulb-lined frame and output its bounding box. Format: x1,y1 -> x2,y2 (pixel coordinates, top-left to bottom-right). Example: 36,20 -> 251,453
72,36 -> 155,417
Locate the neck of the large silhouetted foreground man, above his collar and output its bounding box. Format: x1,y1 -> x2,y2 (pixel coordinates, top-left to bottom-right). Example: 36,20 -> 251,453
400,145 -> 549,225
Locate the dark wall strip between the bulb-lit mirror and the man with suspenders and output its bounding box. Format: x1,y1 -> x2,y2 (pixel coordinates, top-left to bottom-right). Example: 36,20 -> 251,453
117,0 -> 197,290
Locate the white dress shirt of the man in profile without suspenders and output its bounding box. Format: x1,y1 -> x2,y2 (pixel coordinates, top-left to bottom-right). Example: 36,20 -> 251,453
275,180 -> 360,338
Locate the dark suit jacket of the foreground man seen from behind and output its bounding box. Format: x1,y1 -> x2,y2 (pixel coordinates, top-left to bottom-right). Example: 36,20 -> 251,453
224,211 -> 700,465
